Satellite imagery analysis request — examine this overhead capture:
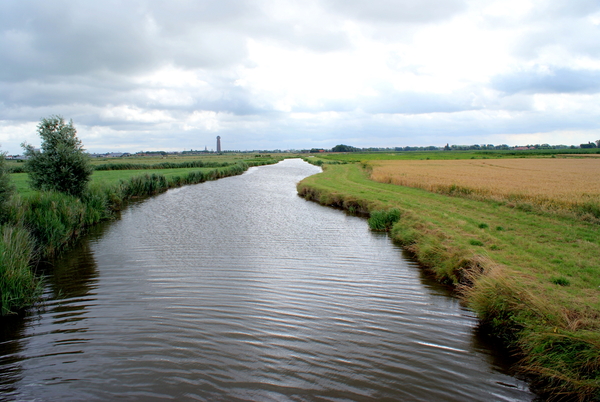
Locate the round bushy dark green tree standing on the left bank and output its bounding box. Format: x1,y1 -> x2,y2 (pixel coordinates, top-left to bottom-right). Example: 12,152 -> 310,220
21,116 -> 93,197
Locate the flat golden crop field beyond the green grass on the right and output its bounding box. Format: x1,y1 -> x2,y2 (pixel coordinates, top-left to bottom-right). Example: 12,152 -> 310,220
370,158 -> 600,218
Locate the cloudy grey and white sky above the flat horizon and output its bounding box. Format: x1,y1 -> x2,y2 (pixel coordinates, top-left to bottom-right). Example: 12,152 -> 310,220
0,0 -> 600,155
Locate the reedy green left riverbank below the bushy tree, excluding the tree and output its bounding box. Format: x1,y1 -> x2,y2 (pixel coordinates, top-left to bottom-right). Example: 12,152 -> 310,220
0,159 -> 279,316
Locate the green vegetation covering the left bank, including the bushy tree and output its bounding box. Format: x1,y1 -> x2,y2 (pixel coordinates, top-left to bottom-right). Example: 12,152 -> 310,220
0,117 -> 281,316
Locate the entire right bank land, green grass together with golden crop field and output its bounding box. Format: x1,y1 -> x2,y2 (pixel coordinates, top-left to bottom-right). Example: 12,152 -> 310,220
298,151 -> 600,401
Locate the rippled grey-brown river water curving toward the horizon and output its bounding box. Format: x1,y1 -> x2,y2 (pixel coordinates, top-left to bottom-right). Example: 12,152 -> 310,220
0,160 -> 534,401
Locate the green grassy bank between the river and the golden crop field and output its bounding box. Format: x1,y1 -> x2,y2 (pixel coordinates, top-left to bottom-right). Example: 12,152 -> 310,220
298,164 -> 600,400
